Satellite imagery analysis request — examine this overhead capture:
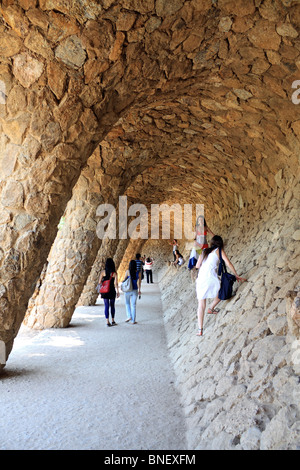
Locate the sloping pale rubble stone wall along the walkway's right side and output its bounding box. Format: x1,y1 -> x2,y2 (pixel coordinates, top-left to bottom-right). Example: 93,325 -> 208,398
150,178 -> 300,450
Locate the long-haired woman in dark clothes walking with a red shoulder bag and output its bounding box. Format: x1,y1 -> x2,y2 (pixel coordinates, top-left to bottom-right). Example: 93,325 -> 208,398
99,258 -> 120,326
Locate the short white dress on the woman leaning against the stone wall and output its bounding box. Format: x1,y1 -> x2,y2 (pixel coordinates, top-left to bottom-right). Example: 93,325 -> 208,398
196,248 -> 221,300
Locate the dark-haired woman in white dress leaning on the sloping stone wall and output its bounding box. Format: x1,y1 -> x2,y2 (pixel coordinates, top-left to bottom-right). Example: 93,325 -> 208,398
196,235 -> 246,336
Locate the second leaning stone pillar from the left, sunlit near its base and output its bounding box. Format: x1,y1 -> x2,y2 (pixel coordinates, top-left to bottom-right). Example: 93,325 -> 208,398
24,149 -> 117,329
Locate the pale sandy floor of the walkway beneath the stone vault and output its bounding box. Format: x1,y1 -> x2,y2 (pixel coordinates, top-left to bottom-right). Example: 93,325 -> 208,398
0,280 -> 186,450
